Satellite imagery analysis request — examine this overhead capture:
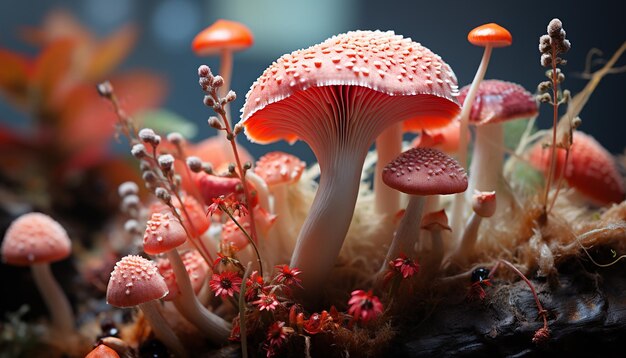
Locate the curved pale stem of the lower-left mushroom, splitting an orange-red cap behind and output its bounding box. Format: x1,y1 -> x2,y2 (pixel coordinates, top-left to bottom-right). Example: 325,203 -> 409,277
167,249 -> 230,344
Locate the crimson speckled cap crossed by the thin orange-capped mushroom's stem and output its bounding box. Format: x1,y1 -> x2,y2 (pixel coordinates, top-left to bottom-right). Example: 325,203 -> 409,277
459,80 -> 539,125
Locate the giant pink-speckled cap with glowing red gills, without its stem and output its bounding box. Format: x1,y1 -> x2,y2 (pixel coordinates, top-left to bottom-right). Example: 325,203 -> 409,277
241,31 -> 459,146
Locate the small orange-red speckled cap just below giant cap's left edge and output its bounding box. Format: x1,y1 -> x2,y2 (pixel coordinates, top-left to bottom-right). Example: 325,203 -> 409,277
254,152 -> 305,186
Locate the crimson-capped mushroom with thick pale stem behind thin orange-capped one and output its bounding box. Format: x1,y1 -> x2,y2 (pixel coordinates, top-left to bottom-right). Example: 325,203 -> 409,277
459,80 -> 539,199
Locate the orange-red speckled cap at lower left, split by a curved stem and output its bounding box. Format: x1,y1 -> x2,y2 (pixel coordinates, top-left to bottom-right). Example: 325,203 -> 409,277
156,250 -> 209,301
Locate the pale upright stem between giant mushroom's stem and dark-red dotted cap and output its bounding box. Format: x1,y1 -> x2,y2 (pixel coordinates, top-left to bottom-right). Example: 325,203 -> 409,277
374,123 -> 402,215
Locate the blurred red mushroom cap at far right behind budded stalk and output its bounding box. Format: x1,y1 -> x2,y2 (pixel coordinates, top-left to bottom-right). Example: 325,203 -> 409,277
529,131 -> 624,205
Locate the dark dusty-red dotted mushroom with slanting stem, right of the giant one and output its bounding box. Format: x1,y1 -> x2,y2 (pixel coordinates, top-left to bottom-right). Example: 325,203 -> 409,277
381,148 -> 467,272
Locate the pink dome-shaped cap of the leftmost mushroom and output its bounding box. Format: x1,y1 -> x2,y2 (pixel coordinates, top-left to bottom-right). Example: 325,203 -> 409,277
2,213 -> 72,266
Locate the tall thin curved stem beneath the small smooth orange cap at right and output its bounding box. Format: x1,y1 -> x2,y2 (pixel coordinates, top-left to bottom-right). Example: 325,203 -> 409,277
450,45 -> 493,236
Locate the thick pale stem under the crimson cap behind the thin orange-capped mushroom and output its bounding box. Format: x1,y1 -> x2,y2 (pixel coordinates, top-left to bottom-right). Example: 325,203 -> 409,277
465,123 -> 504,196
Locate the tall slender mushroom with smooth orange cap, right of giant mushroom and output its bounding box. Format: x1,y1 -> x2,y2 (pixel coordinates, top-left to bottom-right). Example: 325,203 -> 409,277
451,23 -> 513,232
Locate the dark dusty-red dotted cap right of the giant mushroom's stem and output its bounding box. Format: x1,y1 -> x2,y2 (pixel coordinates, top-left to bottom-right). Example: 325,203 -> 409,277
382,148 -> 467,195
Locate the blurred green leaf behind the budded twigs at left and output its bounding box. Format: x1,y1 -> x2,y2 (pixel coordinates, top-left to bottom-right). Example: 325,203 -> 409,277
135,109 -> 198,139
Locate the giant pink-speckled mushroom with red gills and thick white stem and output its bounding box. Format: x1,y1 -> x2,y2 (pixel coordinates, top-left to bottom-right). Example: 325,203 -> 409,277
240,31 -> 459,290
